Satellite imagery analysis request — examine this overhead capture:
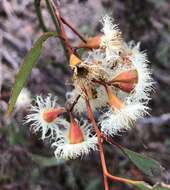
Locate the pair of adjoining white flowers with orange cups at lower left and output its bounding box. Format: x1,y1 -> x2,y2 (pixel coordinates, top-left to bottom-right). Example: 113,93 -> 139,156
26,95 -> 97,159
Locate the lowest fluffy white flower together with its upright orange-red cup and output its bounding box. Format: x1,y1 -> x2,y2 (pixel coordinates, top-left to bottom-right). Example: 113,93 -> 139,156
52,118 -> 98,160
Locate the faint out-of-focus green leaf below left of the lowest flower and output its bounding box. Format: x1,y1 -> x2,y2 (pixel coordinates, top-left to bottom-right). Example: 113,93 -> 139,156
30,154 -> 64,167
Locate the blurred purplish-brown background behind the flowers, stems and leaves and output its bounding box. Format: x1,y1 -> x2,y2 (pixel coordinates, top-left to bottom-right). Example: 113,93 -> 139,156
0,0 -> 170,190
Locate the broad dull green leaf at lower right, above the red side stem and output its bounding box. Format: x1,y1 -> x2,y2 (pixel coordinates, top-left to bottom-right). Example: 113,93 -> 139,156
121,147 -> 163,177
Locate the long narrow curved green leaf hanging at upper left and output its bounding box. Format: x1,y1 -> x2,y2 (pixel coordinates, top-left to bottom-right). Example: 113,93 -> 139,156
7,32 -> 57,114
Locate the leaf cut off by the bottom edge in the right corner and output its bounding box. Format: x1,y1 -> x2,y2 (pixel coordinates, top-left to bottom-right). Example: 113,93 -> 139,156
133,181 -> 170,190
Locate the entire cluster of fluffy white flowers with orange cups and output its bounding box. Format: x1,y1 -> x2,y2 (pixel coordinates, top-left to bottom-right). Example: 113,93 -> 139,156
27,16 -> 153,159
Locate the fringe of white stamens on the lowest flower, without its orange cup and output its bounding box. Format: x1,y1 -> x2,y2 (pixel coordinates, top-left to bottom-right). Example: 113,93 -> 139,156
52,121 -> 97,160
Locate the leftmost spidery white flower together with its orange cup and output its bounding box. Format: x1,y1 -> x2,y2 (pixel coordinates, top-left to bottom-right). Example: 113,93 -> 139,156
26,95 -> 68,140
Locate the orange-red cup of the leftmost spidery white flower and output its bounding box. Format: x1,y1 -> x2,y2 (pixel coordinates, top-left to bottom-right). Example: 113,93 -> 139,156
42,108 -> 65,123
